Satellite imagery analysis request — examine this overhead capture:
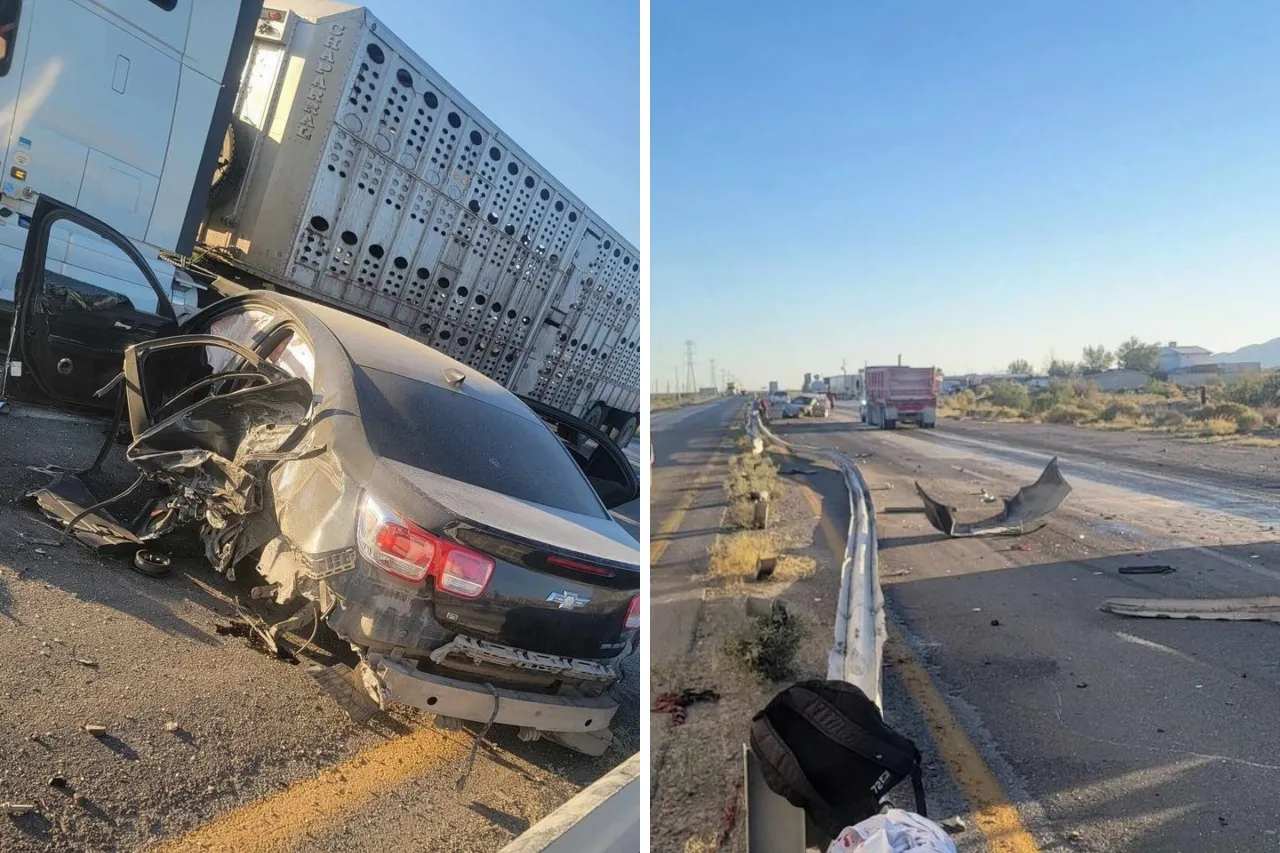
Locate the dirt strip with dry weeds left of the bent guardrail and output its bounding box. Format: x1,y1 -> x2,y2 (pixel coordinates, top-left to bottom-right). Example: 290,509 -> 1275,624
650,445 -> 840,853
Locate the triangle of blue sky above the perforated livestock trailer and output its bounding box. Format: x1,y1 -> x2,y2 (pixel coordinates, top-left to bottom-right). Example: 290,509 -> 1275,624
365,0 -> 640,246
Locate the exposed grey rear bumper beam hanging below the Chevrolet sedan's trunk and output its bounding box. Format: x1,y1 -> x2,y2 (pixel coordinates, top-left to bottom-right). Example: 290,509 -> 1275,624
369,654 -> 618,731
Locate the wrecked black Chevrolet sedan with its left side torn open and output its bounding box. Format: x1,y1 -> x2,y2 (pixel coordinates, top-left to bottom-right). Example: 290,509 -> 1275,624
1,194 -> 640,754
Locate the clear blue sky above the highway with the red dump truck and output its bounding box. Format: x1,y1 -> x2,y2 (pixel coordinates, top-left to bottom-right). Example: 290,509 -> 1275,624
649,0 -> 1280,391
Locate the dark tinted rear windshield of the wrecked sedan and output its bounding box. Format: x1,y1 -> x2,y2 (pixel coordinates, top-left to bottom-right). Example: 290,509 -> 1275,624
356,366 -> 604,517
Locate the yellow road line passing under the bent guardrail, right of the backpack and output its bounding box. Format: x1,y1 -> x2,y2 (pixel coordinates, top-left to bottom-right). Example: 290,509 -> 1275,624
805,473 -> 1039,853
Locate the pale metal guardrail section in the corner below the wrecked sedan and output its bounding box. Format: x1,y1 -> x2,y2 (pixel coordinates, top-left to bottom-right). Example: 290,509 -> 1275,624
500,752 -> 640,853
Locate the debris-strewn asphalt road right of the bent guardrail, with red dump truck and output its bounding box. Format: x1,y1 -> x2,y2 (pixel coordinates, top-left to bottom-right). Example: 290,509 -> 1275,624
774,403 -> 1280,853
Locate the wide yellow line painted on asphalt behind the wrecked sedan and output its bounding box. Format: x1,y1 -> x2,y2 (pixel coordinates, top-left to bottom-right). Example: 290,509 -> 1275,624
152,729 -> 468,853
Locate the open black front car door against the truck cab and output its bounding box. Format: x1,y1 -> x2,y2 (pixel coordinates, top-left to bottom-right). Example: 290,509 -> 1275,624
8,196 -> 178,409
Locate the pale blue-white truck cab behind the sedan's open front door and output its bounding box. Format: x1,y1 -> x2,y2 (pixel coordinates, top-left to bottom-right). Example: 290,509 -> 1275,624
0,0 -> 261,314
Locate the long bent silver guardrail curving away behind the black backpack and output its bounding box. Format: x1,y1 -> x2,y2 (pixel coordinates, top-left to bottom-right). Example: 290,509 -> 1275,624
742,409 -> 886,853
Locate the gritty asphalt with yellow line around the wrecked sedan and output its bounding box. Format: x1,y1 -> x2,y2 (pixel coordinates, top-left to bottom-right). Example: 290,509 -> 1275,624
0,404 -> 639,853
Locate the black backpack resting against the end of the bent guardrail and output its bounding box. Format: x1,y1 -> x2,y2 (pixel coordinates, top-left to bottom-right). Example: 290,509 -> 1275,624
751,680 -> 925,838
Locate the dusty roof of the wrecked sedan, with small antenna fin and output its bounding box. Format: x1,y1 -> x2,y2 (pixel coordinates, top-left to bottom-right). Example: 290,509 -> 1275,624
273,293 -> 539,420
